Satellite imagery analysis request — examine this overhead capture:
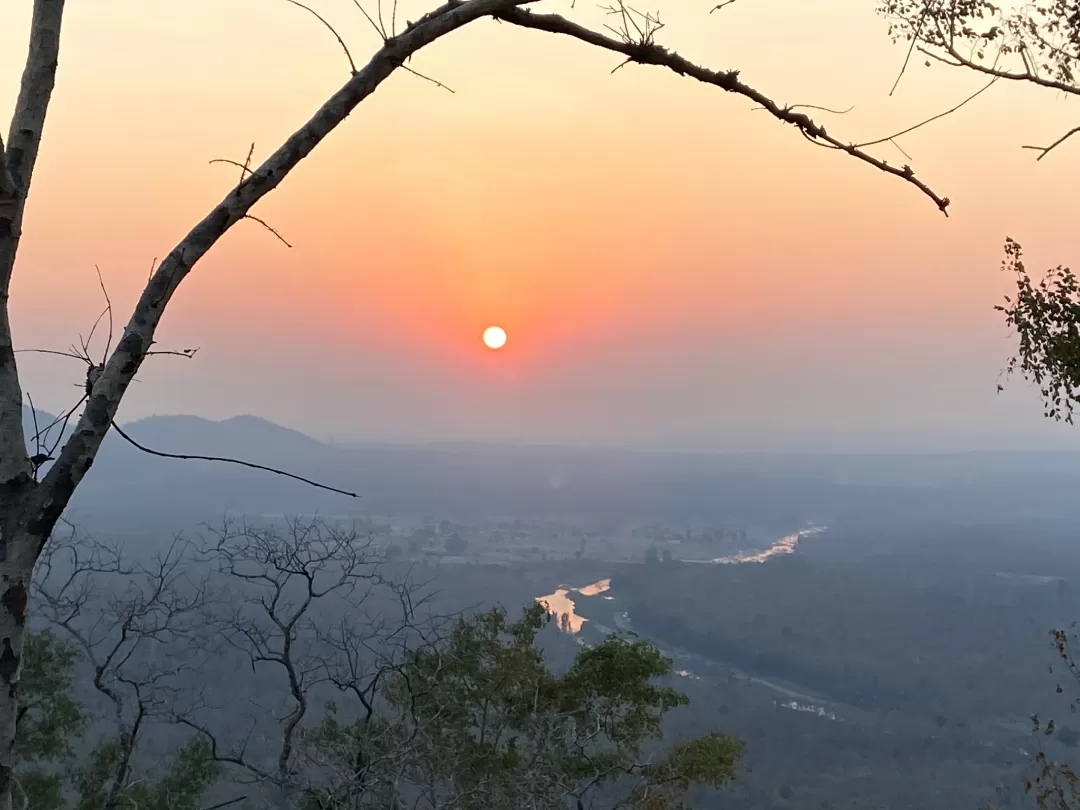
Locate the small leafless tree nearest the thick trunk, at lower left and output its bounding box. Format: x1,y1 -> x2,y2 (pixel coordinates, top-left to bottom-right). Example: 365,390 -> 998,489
31,526 -> 221,810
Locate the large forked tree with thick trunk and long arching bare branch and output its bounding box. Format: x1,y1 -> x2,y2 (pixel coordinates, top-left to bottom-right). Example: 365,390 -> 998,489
0,0 -> 949,810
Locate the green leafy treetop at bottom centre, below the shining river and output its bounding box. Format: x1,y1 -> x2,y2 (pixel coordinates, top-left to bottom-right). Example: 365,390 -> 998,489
307,605 -> 742,810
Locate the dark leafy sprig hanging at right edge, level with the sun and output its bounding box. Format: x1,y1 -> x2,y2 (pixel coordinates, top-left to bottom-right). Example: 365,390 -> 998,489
995,239 -> 1080,423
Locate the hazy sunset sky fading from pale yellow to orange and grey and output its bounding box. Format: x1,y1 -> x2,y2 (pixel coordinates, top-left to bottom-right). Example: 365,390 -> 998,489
0,0 -> 1080,449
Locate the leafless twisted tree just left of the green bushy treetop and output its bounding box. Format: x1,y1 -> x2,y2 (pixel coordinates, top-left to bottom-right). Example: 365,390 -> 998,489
173,518 -> 437,799
